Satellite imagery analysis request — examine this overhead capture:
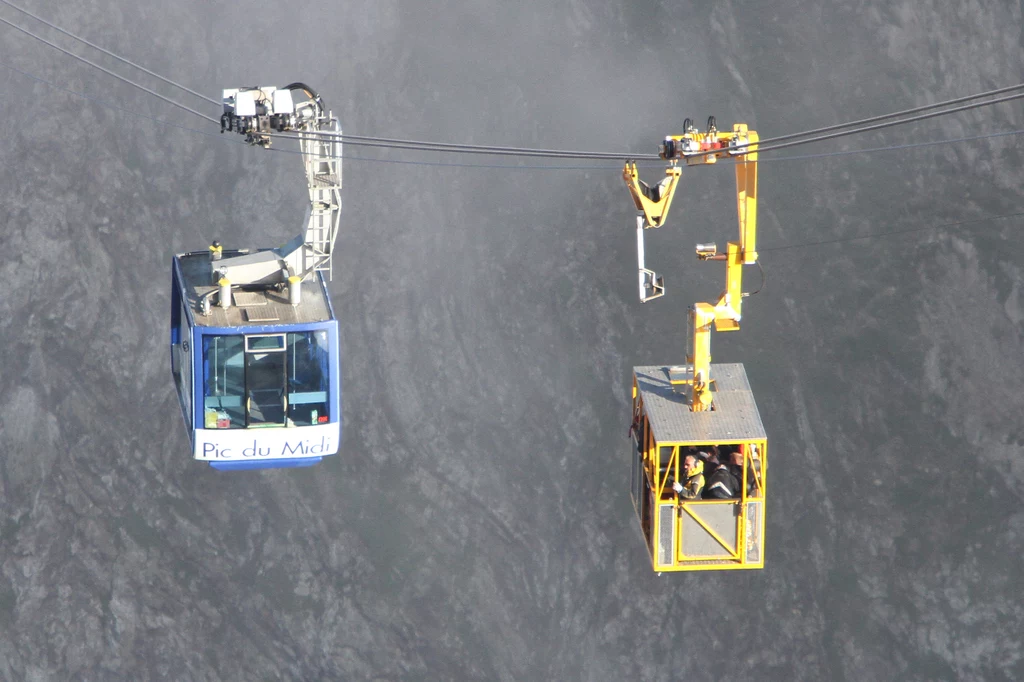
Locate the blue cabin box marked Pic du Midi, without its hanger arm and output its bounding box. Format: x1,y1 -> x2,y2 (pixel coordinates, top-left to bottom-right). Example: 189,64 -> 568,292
171,244 -> 341,470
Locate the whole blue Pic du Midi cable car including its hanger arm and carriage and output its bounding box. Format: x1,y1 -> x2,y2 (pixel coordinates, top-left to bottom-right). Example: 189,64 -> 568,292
171,83 -> 341,470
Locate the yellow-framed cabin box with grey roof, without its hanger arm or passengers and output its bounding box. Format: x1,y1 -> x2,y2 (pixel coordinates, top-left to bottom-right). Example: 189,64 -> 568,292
631,365 -> 768,572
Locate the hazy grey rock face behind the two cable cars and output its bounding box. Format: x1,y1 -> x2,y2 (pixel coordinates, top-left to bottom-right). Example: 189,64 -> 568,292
0,0 -> 1024,680
